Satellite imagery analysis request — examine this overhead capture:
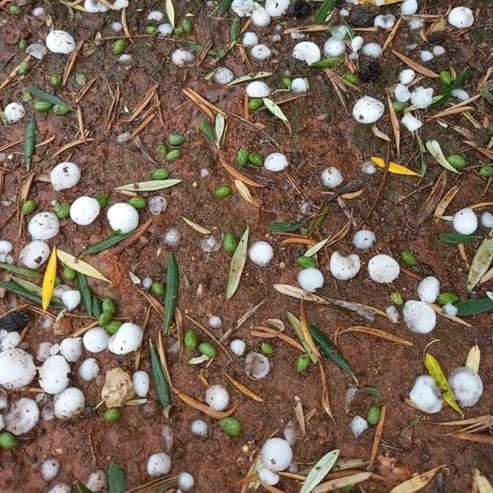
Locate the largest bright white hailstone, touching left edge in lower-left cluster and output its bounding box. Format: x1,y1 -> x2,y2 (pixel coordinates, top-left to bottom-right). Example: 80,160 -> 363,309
0,348 -> 36,390
